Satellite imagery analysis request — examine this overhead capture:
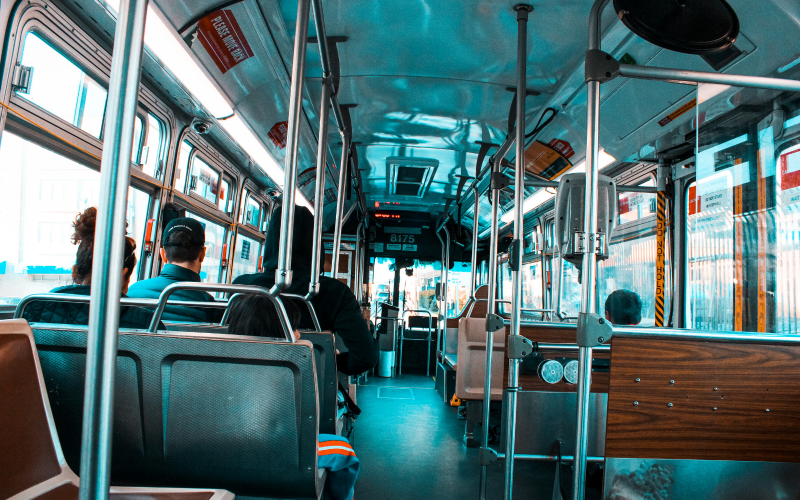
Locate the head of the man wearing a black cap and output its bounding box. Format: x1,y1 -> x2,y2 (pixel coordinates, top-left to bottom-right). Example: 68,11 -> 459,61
161,217 -> 206,274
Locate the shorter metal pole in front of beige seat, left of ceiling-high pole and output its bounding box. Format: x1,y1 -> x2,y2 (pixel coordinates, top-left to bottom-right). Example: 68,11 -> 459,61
480,157 -> 503,500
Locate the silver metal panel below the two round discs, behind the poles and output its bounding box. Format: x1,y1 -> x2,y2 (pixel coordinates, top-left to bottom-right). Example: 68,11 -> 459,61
499,391 -> 608,456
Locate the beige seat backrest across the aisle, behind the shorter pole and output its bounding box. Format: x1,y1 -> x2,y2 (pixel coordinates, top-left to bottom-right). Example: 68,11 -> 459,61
456,318 -> 506,401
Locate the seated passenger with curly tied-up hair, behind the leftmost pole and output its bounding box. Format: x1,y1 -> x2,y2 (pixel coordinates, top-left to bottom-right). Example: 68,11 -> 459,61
23,207 -> 152,328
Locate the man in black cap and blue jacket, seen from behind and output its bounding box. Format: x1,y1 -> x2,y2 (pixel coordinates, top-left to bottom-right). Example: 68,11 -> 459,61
128,217 -> 222,323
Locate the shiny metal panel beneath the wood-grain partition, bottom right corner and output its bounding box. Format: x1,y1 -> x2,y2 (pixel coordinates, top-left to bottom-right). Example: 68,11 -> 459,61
603,458 -> 800,500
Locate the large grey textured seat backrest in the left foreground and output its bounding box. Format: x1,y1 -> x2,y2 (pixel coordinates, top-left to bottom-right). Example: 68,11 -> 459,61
34,326 -> 321,498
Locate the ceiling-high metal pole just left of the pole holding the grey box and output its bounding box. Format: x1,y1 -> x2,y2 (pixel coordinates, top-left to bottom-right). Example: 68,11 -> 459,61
504,4 -> 533,500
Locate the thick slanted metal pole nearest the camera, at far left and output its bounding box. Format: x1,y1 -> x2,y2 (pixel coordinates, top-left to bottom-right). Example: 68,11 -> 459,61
79,0 -> 147,500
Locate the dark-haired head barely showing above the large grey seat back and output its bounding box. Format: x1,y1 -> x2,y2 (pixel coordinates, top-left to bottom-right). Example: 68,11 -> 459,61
228,295 -> 300,338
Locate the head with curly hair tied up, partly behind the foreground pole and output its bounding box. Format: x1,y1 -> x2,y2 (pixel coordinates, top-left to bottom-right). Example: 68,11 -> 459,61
71,207 -> 136,294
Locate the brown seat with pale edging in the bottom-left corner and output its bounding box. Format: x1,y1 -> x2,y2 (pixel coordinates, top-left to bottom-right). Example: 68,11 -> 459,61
0,319 -> 234,500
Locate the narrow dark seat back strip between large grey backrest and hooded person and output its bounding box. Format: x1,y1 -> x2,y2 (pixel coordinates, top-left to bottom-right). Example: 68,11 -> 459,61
300,331 -> 339,434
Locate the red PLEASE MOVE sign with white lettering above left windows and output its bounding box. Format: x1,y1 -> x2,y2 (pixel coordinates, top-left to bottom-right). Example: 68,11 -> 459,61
197,10 -> 253,74
